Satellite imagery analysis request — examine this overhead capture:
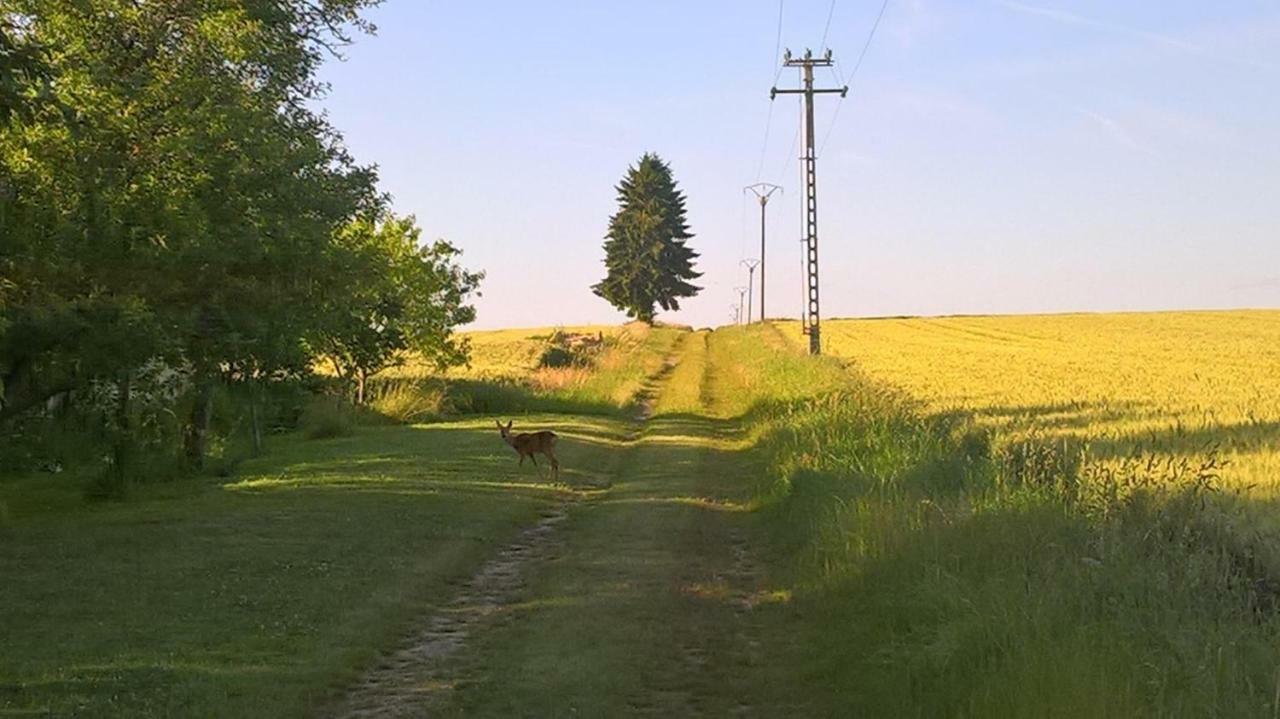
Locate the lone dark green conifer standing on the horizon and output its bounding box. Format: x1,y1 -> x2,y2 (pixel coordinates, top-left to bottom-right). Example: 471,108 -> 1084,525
591,152 -> 701,322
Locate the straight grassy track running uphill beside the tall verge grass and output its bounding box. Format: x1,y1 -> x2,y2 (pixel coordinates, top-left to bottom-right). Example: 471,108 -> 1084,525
409,333 -> 800,716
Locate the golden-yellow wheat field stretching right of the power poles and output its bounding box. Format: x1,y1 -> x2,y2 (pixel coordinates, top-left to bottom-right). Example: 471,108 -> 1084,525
780,311 -> 1280,498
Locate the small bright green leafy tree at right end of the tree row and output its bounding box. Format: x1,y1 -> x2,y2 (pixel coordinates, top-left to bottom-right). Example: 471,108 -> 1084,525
314,215 -> 483,403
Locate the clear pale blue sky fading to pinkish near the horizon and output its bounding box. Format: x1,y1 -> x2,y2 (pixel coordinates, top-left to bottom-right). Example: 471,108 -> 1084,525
312,0 -> 1280,328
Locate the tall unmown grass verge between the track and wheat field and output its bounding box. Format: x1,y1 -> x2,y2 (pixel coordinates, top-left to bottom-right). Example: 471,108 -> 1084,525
712,323 -> 1280,716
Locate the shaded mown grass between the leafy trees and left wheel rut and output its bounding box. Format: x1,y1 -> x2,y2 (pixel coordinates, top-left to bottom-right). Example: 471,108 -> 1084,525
0,416 -> 622,716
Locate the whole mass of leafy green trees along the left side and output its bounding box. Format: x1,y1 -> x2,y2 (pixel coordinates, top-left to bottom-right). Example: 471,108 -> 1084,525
0,0 -> 481,478
